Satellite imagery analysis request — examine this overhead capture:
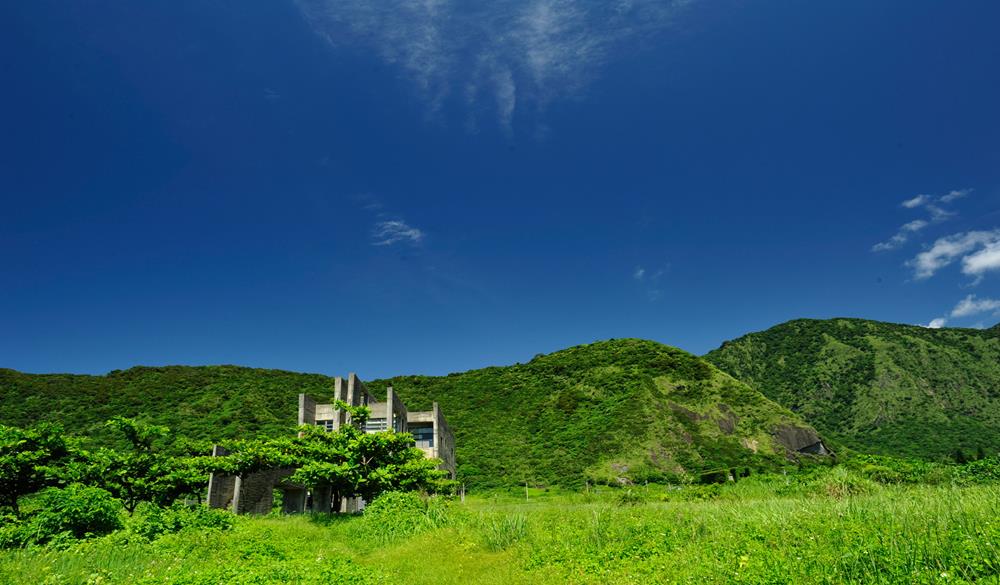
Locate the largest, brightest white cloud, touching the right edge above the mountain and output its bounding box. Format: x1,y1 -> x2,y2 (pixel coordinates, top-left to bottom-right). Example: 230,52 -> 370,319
907,229 -> 1000,280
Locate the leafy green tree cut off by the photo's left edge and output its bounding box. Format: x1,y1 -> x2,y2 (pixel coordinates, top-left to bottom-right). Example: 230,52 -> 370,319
0,423 -> 70,515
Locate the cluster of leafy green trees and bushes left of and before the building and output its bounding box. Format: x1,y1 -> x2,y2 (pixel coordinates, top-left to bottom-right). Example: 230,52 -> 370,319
0,405 -> 451,548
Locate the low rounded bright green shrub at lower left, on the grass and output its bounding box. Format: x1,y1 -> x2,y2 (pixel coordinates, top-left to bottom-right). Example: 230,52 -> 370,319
20,484 -> 123,545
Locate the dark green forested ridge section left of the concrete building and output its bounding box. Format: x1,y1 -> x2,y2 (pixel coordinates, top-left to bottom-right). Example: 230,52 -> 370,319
0,366 -> 333,446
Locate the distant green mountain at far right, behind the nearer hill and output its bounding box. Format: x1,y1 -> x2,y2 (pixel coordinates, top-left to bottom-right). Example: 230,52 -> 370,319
705,319 -> 1000,459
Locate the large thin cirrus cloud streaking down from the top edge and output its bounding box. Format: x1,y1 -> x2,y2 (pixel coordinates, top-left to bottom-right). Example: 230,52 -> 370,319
296,0 -> 693,131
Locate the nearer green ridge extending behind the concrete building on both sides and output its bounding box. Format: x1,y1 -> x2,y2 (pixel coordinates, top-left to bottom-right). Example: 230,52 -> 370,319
0,340 -> 819,487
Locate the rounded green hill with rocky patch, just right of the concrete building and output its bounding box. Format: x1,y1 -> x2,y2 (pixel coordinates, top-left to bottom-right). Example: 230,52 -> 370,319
369,339 -> 812,487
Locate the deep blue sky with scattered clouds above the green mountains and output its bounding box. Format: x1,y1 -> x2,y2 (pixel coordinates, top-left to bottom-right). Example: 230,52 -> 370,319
0,0 -> 1000,378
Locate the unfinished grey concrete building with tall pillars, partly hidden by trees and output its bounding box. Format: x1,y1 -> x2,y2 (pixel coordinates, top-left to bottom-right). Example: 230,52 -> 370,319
208,373 -> 455,514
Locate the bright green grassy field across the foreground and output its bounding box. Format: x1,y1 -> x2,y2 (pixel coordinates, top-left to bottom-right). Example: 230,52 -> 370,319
0,481 -> 1000,585
